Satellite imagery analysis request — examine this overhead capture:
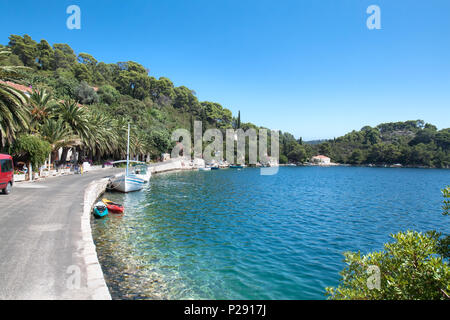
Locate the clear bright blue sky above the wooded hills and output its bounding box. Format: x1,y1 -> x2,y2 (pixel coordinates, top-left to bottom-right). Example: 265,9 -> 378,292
0,0 -> 450,140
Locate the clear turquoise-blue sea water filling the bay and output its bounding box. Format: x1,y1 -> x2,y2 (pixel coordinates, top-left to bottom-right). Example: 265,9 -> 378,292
92,167 -> 450,299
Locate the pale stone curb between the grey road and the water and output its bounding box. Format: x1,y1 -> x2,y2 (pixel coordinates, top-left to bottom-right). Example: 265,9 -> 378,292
81,178 -> 111,300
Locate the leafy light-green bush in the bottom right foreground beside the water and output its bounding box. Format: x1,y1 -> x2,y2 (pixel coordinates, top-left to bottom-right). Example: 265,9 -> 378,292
326,231 -> 450,300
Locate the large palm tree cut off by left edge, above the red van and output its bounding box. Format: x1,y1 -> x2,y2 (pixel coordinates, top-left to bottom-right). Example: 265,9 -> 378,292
0,51 -> 29,147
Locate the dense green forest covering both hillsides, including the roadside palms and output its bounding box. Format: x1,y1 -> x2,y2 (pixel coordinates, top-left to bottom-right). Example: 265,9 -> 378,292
0,35 -> 450,167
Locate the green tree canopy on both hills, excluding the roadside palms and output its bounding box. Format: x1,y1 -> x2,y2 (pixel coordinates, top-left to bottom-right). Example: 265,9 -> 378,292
0,35 -> 450,167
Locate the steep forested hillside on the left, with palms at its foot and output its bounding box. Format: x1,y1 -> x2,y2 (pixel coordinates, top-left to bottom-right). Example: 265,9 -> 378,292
0,35 -> 270,160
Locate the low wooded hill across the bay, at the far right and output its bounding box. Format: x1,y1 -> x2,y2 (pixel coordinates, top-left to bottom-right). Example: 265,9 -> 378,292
312,120 -> 450,168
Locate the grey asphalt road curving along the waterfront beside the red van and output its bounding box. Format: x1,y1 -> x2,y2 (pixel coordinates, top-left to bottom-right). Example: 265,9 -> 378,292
0,169 -> 118,299
